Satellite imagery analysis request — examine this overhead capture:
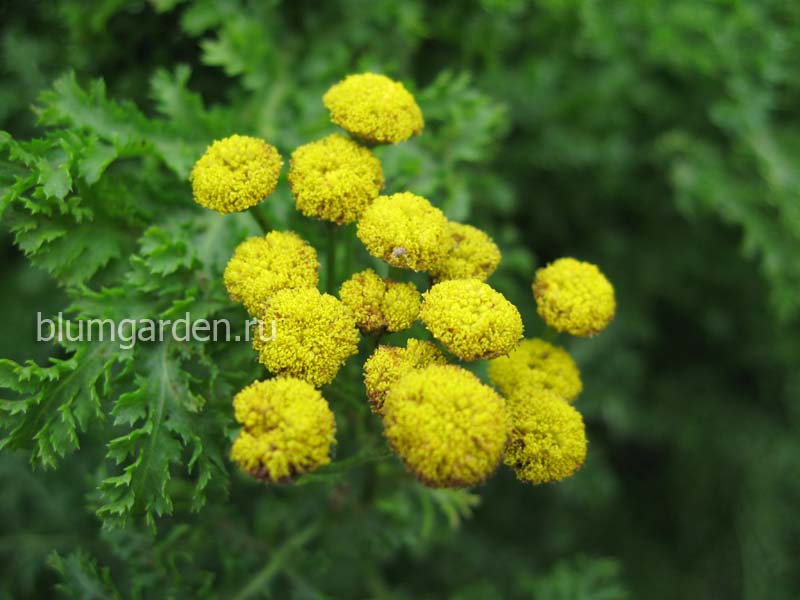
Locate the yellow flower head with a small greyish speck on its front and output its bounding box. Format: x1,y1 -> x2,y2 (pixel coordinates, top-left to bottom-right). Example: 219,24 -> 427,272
358,192 -> 452,271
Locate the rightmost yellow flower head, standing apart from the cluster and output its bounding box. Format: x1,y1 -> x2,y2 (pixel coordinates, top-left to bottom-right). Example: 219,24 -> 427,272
533,258 -> 616,337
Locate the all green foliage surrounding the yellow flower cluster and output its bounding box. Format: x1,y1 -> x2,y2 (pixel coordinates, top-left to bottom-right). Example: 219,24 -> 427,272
0,0 -> 800,600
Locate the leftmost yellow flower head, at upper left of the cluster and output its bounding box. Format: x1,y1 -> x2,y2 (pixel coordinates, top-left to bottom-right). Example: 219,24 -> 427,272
189,135 -> 283,213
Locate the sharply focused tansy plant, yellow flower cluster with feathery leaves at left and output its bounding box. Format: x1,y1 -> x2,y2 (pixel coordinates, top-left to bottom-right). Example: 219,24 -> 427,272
0,69 -> 615,535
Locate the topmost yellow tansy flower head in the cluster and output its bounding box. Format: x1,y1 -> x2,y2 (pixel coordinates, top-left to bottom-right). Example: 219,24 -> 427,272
322,73 -> 425,144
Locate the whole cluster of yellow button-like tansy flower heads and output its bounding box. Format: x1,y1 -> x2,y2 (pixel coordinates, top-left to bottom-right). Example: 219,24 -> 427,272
190,73 -> 615,487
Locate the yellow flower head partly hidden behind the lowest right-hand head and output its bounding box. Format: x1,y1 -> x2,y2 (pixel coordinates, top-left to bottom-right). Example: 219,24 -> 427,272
489,338 -> 583,402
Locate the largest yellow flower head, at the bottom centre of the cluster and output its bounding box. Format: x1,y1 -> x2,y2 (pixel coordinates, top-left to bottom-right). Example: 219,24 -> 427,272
383,365 -> 508,487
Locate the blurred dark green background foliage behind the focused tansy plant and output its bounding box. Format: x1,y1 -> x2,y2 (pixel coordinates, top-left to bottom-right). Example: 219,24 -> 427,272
0,0 -> 800,600
